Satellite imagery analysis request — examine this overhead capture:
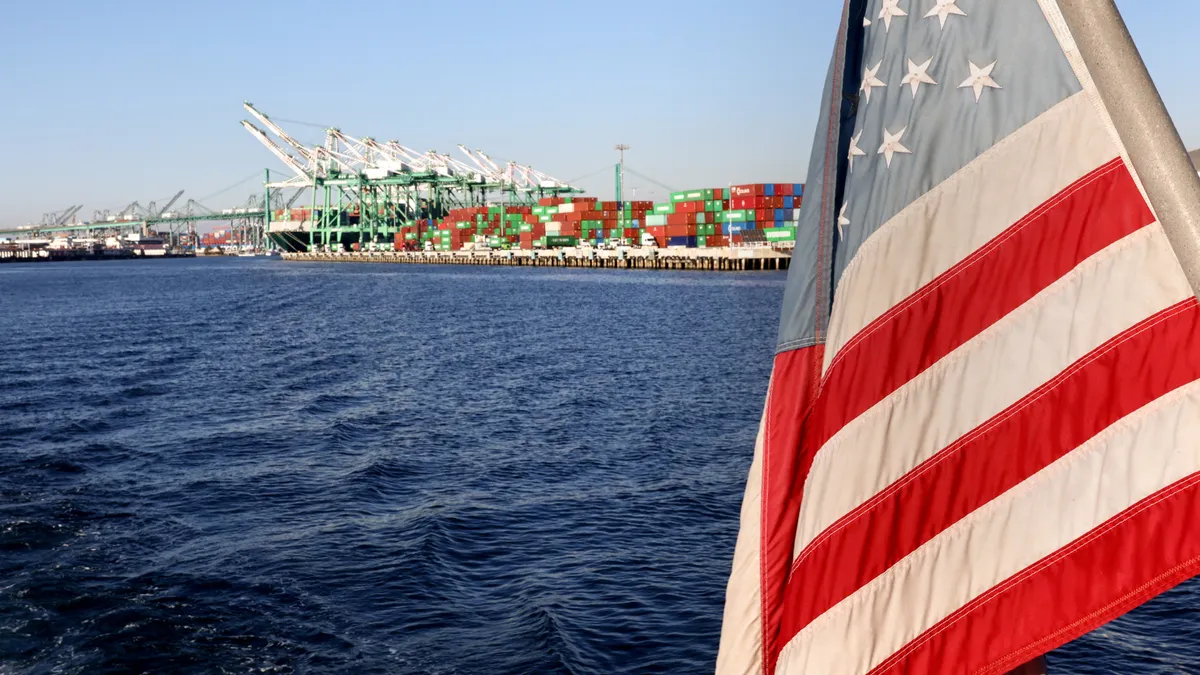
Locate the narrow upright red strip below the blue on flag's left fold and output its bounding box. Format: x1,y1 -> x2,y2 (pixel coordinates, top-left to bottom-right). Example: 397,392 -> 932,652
758,345 -> 824,675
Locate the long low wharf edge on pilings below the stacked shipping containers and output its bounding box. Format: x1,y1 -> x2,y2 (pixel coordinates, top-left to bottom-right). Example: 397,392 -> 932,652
283,247 -> 792,271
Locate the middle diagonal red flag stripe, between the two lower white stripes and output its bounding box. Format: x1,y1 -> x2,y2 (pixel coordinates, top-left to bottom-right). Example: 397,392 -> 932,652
781,298 -> 1200,644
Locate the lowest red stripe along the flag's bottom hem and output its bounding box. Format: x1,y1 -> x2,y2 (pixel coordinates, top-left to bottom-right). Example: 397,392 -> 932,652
870,473 -> 1200,675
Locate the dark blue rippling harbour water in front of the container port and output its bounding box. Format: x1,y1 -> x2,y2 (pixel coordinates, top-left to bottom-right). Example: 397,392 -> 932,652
0,258 -> 1200,675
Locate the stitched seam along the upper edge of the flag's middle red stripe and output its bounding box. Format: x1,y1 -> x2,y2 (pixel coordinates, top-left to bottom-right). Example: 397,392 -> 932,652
792,298 -> 1196,573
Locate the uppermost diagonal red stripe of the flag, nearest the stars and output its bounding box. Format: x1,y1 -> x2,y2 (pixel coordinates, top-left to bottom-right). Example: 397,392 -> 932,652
811,159 -> 1154,447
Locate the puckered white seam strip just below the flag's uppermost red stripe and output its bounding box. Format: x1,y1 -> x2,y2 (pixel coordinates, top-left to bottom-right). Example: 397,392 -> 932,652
804,223 -> 1165,530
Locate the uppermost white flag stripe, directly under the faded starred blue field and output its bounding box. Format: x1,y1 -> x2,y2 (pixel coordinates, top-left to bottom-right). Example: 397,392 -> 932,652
824,92 -> 1118,371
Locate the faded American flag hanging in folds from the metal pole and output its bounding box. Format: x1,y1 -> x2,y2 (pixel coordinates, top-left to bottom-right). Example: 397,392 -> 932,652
718,0 -> 1200,675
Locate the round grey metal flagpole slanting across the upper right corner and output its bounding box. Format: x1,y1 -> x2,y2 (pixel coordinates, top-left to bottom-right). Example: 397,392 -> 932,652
1058,0 -> 1200,297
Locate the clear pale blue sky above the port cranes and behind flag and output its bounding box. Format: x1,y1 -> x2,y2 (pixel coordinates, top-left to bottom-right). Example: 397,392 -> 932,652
0,0 -> 1200,225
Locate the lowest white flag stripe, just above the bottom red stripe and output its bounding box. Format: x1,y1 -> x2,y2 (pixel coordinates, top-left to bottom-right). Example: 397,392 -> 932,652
778,382 -> 1200,675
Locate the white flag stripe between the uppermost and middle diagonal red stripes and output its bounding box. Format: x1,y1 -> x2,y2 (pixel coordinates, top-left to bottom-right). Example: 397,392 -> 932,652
794,223 -> 1192,555
